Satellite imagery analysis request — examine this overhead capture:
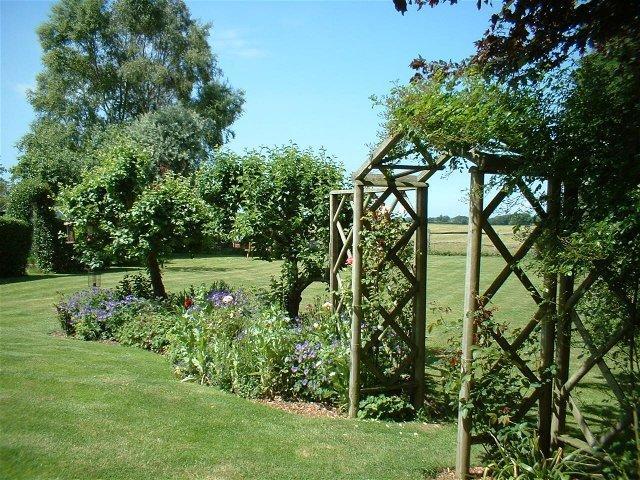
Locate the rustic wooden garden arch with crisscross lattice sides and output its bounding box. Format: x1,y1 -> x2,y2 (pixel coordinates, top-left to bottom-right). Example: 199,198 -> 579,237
329,134 -> 637,478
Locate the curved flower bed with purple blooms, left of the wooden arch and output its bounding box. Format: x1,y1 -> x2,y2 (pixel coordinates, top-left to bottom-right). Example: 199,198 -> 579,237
56,277 -> 349,405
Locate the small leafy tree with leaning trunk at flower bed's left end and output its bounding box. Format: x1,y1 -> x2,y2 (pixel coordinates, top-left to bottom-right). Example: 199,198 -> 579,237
61,135 -> 212,297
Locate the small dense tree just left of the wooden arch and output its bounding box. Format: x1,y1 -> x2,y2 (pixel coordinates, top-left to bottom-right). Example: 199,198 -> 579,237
235,145 -> 343,317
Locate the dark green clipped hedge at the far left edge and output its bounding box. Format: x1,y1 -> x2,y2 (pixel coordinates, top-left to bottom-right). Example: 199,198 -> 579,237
0,217 -> 31,277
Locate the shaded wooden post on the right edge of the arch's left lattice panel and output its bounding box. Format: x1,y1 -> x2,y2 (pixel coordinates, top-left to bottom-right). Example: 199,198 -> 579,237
412,187 -> 428,410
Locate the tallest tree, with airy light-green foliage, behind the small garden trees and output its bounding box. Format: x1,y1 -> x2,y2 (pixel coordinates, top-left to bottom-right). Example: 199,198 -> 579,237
12,0 -> 243,270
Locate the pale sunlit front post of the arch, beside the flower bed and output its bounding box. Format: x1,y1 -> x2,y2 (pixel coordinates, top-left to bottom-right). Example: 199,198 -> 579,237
349,180 -> 364,418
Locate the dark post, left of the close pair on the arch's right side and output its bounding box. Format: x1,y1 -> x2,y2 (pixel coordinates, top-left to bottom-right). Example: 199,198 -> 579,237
538,179 -> 559,456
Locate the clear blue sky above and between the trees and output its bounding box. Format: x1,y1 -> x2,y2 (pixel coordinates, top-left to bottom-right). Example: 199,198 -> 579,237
0,0 -> 499,216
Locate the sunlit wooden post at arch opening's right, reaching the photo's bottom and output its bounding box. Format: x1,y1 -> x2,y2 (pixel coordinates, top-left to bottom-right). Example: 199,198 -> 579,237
456,167 -> 484,479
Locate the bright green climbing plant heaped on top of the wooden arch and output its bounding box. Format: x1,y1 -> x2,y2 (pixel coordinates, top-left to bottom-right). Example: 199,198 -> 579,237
380,66 -> 550,163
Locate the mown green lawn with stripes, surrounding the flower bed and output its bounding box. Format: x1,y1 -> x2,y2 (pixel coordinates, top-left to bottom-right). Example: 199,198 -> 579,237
0,256 -> 608,479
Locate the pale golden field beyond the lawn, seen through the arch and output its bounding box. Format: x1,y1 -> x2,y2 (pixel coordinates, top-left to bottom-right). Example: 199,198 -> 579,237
429,223 -> 522,255
